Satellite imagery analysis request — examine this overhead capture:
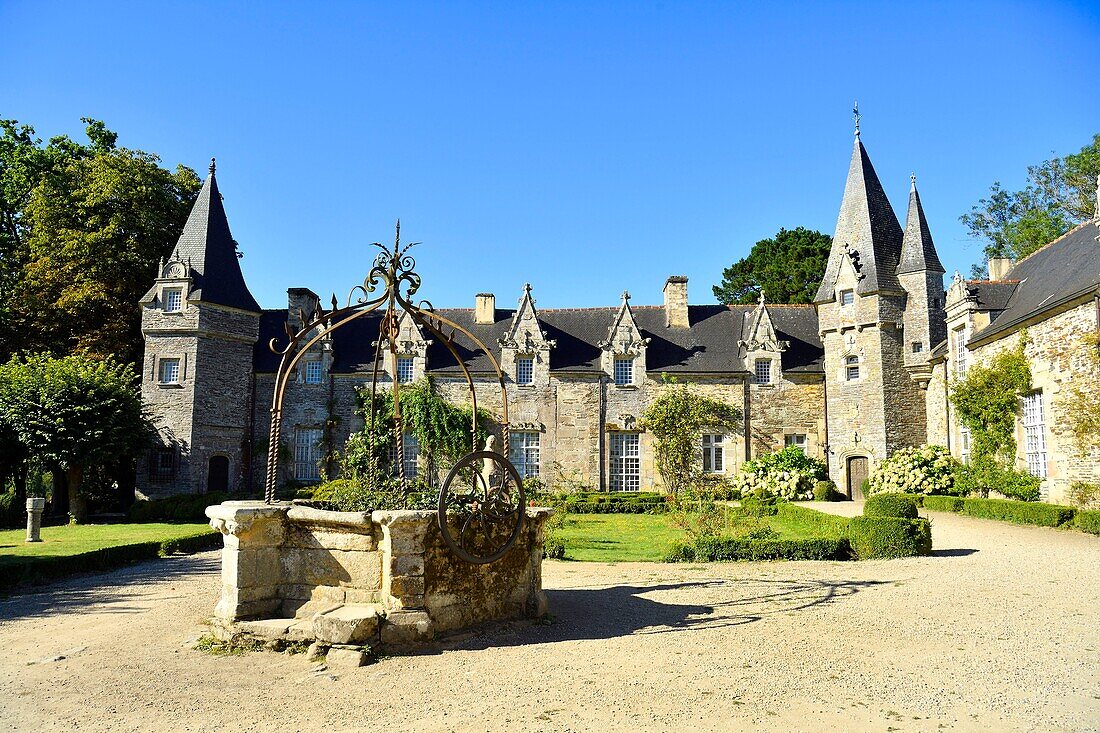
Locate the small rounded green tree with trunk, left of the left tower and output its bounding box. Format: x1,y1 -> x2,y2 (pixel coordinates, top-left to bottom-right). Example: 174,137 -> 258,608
0,354 -> 153,522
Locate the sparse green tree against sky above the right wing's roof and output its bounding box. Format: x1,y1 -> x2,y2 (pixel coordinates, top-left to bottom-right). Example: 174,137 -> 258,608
959,134 -> 1100,268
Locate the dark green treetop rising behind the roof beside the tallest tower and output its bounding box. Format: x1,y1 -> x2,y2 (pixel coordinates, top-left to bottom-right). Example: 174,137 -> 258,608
714,227 -> 833,305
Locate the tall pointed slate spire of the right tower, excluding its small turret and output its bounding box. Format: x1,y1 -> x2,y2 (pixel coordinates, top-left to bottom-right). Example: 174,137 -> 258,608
814,136 -> 906,303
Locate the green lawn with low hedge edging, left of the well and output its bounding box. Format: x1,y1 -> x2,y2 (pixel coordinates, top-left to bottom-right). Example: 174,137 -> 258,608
0,523 -> 221,589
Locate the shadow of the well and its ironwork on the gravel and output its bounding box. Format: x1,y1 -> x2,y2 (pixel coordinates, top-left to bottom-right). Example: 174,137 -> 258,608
433,580 -> 890,654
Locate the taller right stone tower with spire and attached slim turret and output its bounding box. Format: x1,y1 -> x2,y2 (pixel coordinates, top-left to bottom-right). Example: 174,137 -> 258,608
814,127 -> 943,497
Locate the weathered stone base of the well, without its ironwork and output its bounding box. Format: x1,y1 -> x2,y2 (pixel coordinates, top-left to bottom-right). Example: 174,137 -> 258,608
206,501 -> 551,657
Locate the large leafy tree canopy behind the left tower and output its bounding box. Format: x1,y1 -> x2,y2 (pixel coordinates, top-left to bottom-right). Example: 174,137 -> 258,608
0,118 -> 200,362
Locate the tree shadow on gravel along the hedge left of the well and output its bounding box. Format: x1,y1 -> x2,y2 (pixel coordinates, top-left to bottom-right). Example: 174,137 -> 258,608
0,551 -> 221,621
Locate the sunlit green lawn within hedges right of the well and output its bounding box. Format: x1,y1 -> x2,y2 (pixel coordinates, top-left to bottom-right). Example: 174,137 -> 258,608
559,506 -> 844,562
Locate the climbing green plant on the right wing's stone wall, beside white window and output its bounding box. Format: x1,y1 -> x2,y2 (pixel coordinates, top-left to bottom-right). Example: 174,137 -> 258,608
950,332 -> 1032,466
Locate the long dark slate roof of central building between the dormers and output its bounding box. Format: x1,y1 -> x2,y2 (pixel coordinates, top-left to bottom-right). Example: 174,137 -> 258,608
254,305 -> 824,374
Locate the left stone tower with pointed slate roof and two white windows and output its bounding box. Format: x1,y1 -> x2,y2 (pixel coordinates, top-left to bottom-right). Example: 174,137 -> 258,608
138,160 -> 260,497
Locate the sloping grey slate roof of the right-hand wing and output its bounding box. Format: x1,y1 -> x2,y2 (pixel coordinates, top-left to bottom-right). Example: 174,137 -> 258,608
970,220 -> 1100,343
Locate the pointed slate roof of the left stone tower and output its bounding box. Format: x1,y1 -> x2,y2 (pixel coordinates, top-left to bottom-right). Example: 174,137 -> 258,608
158,162 -> 261,313
